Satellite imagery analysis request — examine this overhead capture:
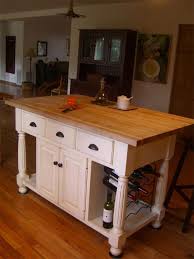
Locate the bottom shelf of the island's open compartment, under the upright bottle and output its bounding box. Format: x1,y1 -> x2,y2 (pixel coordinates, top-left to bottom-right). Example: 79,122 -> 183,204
88,201 -> 157,240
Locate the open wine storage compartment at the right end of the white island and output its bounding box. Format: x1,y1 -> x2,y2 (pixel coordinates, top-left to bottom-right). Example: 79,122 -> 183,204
86,162 -> 157,240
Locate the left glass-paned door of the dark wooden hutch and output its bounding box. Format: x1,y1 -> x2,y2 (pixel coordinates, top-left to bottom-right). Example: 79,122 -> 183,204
81,31 -> 105,63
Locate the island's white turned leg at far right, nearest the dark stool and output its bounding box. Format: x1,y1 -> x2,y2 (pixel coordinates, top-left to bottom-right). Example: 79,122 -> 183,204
152,159 -> 169,229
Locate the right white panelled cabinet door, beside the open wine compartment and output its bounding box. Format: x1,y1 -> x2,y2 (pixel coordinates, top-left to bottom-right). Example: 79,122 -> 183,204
59,150 -> 87,219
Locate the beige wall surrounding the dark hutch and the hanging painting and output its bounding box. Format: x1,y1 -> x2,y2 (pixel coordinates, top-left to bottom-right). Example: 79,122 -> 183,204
69,0 -> 194,111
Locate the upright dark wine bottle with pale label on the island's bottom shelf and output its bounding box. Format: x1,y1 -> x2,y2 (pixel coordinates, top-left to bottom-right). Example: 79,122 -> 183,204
103,190 -> 114,229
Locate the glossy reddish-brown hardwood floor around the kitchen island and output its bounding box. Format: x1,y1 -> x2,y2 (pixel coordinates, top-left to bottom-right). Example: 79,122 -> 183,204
0,84 -> 194,259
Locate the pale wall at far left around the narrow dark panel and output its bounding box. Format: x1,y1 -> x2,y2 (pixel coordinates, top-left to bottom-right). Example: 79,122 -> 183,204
0,21 -> 24,85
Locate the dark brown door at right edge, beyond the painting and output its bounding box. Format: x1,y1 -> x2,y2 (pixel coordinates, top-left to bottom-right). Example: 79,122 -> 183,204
170,24 -> 194,140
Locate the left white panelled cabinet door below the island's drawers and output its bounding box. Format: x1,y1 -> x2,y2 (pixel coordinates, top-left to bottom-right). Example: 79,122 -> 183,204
37,140 -> 59,203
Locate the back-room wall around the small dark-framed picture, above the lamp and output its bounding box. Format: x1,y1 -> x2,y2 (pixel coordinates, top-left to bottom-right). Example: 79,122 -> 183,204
24,16 -> 70,80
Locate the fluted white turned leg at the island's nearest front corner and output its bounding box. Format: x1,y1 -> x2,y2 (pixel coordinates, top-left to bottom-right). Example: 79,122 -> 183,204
109,176 -> 128,256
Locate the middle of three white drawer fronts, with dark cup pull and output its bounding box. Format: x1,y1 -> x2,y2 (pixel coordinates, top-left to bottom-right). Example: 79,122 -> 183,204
46,120 -> 76,148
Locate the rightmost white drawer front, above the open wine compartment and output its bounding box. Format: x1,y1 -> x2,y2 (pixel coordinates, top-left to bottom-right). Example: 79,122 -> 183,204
77,131 -> 113,164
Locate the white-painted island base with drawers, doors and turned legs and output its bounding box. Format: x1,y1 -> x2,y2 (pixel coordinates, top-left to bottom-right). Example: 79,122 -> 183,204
16,109 -> 175,256
